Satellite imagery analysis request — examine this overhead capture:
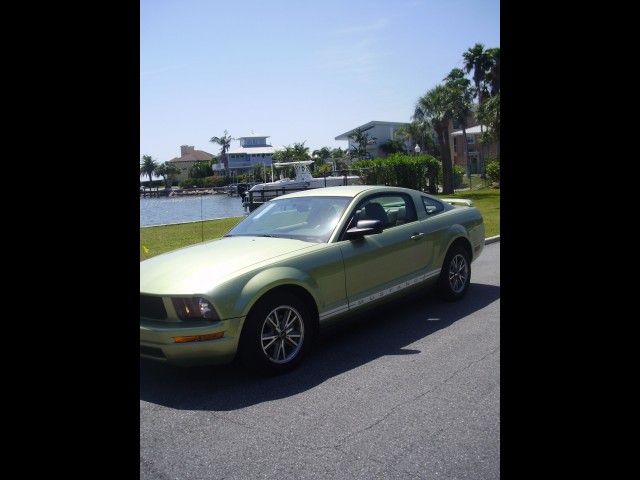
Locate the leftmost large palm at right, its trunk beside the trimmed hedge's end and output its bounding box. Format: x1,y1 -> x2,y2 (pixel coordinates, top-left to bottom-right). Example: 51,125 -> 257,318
412,85 -> 454,195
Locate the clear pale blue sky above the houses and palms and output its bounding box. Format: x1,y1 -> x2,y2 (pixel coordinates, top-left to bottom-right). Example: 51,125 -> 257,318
138,0 -> 500,163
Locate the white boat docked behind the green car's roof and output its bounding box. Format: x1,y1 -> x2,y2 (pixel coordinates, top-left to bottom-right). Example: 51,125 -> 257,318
245,160 -> 362,202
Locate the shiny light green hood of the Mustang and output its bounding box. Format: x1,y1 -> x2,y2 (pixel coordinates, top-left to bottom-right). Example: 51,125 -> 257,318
140,237 -> 323,295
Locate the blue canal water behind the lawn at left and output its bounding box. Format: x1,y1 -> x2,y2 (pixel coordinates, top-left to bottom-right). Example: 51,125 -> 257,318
140,194 -> 248,227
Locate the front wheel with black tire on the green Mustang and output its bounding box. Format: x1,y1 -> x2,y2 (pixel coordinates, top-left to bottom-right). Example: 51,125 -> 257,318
238,293 -> 311,374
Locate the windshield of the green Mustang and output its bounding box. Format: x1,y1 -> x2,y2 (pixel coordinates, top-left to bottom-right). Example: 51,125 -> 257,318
225,197 -> 351,243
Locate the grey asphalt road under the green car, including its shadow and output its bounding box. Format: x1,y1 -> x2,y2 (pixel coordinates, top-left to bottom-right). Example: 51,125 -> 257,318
140,241 -> 500,480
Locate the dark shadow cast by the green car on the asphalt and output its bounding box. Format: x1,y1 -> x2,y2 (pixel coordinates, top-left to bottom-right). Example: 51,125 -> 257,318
140,283 -> 500,411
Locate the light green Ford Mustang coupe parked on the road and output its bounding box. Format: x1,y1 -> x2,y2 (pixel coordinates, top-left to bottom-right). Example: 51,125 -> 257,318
140,185 -> 485,373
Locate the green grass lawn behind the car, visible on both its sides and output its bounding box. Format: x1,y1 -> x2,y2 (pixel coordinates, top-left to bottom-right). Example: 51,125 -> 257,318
140,188 -> 500,261
